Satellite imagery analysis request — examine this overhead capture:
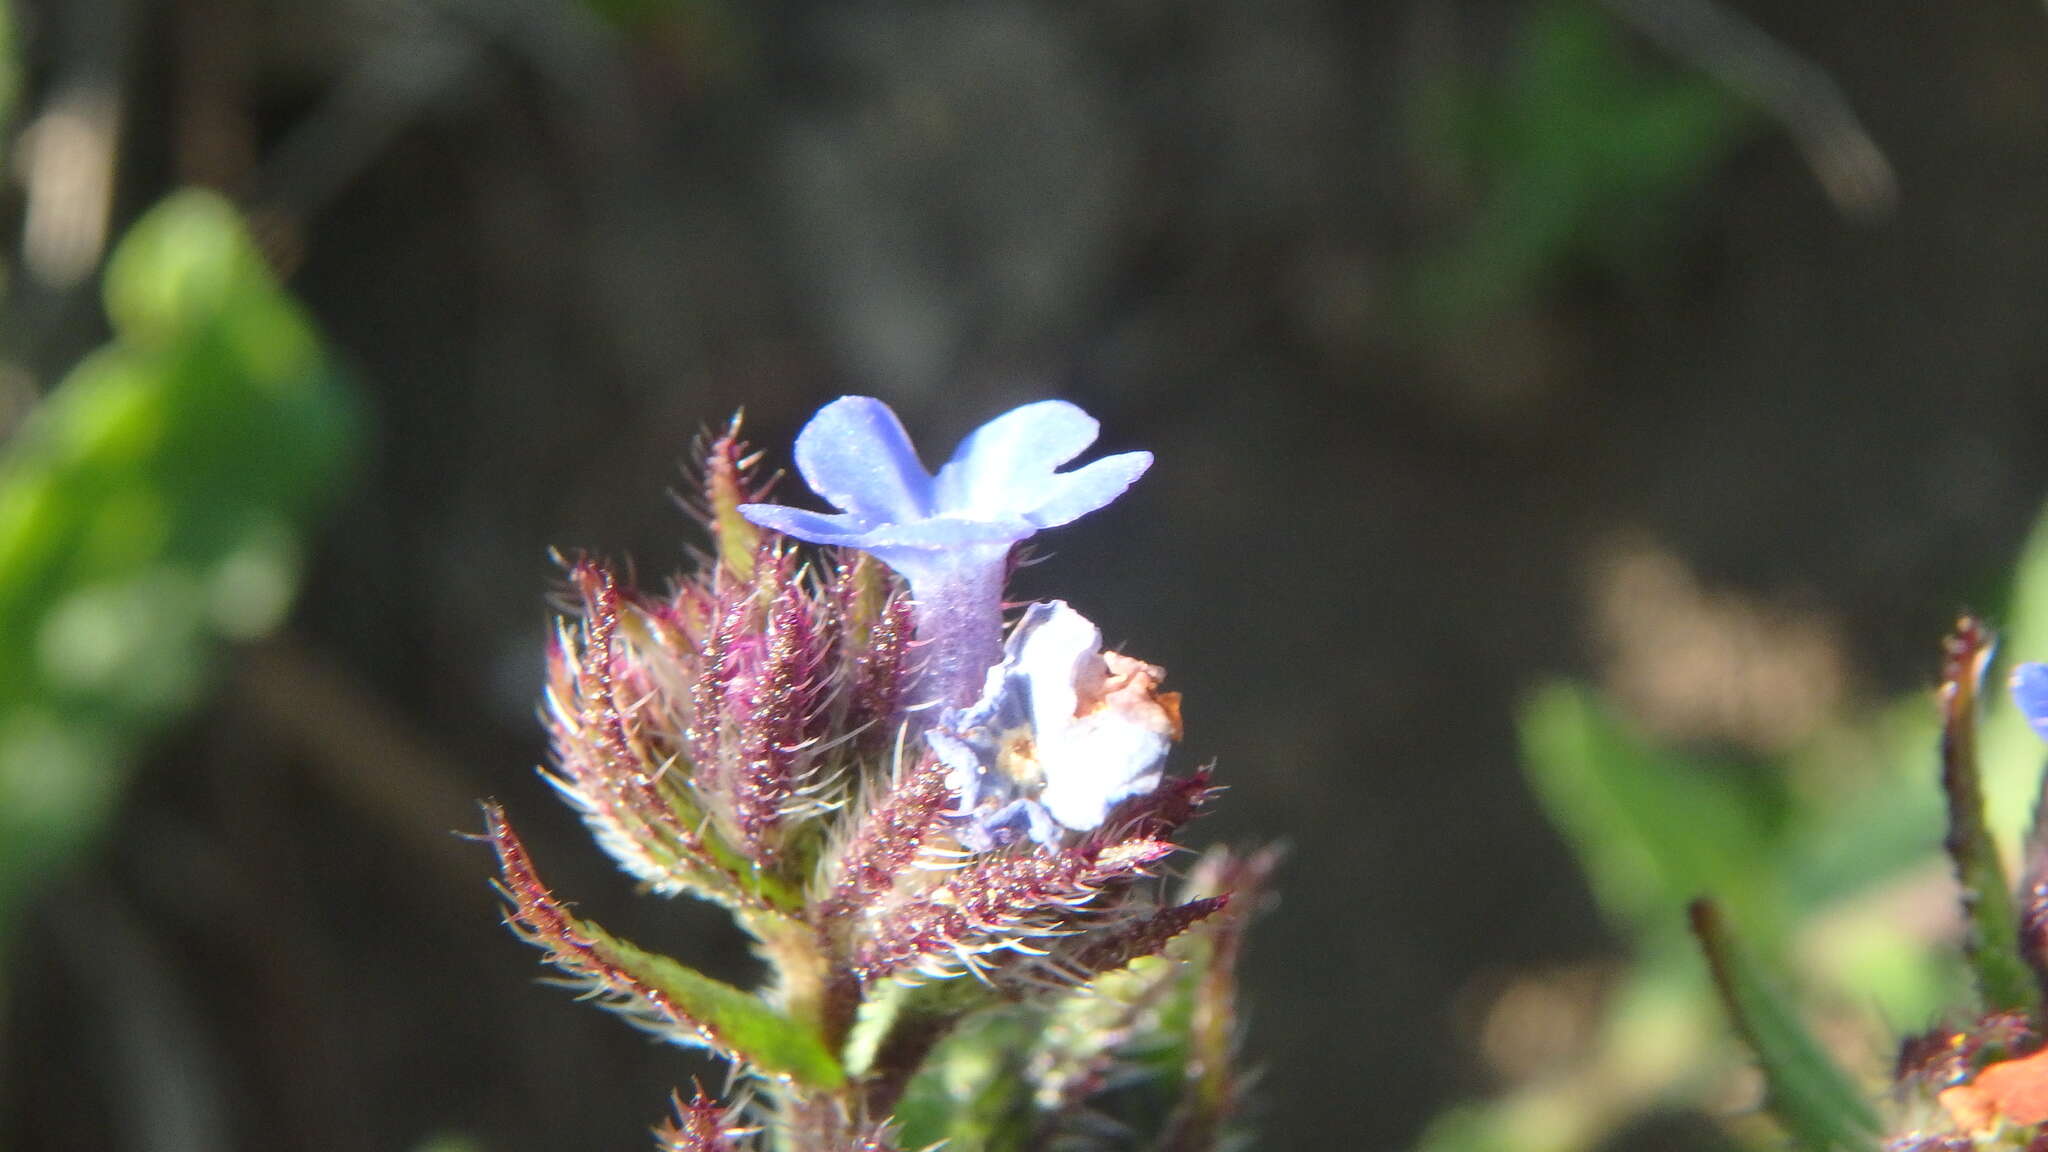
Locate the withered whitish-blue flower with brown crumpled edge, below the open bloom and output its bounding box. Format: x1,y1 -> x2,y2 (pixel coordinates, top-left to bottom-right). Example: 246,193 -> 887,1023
926,601 -> 1180,851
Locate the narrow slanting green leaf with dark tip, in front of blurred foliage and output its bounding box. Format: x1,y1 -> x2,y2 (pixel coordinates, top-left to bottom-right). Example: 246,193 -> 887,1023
1692,900 -> 1878,1152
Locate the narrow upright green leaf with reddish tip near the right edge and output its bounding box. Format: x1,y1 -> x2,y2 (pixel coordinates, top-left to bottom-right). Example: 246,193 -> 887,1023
1942,617 -> 2036,1011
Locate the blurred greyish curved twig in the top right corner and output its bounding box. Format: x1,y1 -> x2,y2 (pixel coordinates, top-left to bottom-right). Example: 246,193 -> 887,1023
1602,0 -> 1898,219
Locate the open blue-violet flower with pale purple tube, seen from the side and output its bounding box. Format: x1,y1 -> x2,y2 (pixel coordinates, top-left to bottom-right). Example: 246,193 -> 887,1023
739,396 -> 1151,705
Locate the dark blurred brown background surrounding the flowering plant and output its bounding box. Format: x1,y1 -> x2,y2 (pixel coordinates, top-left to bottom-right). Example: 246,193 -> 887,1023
0,0 -> 2048,1152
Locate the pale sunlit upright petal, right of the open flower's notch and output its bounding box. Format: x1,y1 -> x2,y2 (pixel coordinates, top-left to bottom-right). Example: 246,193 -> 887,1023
934,400 -> 1102,517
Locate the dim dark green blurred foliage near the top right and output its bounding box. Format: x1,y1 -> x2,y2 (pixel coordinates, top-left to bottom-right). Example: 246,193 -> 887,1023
1413,0 -> 1751,332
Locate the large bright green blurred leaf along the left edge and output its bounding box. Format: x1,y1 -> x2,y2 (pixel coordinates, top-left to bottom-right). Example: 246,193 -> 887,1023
0,193 -> 354,943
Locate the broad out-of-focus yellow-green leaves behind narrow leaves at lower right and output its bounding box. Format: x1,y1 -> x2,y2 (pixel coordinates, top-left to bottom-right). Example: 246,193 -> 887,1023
1421,610 -> 1982,1152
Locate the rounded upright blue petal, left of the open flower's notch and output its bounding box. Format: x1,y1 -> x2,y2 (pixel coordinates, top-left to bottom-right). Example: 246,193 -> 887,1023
791,396 -> 932,520
